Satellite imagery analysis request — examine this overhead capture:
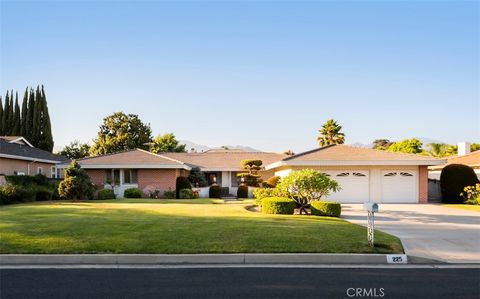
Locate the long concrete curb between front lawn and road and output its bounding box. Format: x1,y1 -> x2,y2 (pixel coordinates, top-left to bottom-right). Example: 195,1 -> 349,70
0,253 -> 398,265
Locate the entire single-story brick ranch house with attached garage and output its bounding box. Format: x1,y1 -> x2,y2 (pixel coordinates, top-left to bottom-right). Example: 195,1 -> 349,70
65,145 -> 445,203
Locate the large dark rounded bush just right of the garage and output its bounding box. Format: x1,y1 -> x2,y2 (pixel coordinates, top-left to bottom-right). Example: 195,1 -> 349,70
440,164 -> 479,203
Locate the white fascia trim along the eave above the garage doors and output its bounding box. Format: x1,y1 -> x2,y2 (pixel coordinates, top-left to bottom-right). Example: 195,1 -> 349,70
265,160 -> 445,170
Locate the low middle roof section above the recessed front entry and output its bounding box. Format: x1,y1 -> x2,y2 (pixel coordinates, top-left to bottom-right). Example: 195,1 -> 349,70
162,150 -> 287,171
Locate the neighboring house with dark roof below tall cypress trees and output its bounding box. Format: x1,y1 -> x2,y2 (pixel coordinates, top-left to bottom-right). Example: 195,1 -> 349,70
0,136 -> 69,178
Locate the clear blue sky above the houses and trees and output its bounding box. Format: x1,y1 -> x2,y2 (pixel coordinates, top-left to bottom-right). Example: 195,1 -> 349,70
0,0 -> 480,152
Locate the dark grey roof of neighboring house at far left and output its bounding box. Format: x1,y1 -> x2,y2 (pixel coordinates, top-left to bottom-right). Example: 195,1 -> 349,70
0,138 -> 70,164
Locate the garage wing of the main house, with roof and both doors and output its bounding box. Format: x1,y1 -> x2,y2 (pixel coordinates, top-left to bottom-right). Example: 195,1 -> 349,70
265,145 -> 445,203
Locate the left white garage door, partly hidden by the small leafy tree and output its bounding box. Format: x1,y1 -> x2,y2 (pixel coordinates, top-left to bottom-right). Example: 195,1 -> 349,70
324,170 -> 369,203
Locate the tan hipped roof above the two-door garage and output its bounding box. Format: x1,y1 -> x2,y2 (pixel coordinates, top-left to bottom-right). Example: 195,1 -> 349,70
266,144 -> 445,169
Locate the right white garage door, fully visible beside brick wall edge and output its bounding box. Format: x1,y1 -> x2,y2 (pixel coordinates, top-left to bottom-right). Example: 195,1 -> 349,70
382,170 -> 418,203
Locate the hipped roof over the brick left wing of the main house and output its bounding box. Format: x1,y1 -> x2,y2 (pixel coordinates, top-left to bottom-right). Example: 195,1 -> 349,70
74,149 -> 190,169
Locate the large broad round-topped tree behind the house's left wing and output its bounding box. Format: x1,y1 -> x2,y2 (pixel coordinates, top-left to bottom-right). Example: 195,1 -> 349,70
91,112 -> 152,156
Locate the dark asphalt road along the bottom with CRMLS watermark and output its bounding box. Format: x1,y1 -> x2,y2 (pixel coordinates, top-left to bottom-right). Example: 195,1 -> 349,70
0,268 -> 480,299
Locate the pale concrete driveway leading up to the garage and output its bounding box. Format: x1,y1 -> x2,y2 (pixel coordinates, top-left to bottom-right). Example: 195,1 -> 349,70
342,204 -> 480,263
